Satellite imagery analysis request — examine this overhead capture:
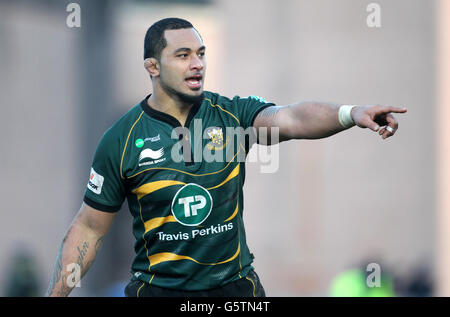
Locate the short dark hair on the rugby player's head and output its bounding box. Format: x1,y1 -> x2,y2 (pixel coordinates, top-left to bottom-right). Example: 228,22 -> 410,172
144,18 -> 194,60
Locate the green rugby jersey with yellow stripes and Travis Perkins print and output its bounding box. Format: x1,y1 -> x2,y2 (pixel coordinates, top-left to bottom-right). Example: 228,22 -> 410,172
84,91 -> 273,290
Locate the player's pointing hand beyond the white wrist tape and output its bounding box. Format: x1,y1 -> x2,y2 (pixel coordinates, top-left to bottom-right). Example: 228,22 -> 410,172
350,105 -> 407,139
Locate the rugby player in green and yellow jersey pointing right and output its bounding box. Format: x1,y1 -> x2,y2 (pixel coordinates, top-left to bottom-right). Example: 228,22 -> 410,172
47,18 -> 406,297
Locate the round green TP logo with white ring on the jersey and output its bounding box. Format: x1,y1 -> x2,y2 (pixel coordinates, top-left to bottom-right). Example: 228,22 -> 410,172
171,183 -> 212,226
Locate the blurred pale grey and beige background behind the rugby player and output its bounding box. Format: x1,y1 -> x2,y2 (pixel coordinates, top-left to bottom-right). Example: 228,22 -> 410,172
0,0 -> 450,296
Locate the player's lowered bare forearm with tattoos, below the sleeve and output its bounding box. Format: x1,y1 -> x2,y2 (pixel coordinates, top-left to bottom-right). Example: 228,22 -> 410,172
46,203 -> 117,296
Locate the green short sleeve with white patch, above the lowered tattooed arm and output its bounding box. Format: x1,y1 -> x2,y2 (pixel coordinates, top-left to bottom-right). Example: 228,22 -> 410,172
83,130 -> 126,212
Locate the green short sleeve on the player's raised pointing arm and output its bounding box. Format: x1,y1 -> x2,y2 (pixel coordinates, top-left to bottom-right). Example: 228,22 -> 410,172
233,96 -> 275,129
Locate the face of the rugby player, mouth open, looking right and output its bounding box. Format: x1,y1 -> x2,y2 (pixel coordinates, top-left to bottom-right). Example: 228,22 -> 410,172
159,28 -> 206,102
